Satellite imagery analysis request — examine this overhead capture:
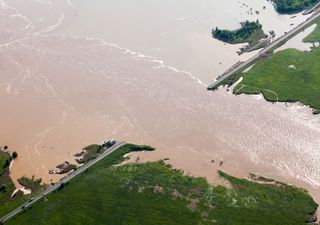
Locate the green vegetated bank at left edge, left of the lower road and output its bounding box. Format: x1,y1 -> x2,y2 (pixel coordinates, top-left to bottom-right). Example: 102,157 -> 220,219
0,148 -> 43,217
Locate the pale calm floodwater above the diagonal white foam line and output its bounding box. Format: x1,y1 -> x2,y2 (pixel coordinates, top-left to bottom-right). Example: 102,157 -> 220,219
55,0 -> 306,84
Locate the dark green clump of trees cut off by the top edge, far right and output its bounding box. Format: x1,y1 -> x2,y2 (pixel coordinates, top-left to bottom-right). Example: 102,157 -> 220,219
272,0 -> 320,14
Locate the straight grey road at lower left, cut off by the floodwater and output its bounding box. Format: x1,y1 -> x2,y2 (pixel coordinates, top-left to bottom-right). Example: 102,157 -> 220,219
0,142 -> 126,222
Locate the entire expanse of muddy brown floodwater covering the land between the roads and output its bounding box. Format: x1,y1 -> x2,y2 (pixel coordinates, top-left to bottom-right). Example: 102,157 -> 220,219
0,0 -> 320,204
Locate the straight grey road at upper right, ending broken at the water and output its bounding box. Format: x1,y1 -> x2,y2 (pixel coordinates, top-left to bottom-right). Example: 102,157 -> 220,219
207,10 -> 320,90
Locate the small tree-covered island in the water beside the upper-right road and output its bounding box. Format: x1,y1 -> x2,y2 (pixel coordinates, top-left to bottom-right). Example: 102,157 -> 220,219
212,21 -> 267,54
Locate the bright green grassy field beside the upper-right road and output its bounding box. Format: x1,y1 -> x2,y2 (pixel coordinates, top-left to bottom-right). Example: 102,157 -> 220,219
233,19 -> 320,113
